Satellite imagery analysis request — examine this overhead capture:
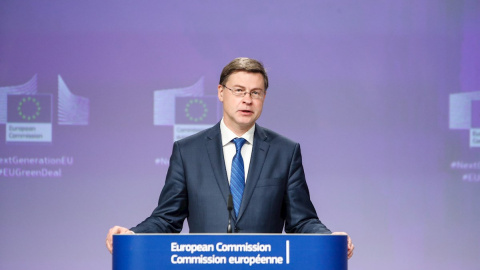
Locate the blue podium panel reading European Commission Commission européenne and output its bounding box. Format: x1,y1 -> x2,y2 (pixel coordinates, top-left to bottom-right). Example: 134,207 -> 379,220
113,234 -> 348,270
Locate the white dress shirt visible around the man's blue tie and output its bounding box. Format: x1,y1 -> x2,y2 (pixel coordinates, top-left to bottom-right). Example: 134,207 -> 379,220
220,118 -> 255,183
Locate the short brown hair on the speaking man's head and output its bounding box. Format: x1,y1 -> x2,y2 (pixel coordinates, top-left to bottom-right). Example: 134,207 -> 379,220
219,57 -> 268,91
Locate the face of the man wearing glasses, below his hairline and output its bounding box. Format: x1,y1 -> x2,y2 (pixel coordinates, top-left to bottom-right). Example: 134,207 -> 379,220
218,71 -> 266,136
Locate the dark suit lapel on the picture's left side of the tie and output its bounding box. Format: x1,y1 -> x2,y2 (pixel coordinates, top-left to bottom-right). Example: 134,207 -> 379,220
206,123 -> 230,208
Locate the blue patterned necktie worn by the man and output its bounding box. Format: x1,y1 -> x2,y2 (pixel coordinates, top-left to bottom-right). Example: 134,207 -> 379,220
230,138 -> 246,217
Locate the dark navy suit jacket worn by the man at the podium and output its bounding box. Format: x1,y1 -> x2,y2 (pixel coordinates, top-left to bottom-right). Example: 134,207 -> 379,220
132,123 -> 330,233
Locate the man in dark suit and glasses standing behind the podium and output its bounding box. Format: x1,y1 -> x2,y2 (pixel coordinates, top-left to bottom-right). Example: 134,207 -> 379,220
106,58 -> 354,258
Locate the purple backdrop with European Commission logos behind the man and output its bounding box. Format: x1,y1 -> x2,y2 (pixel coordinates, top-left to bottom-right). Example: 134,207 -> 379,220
0,0 -> 480,270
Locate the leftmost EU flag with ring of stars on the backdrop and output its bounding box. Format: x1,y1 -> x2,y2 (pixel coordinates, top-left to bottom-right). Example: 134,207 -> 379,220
7,94 -> 52,123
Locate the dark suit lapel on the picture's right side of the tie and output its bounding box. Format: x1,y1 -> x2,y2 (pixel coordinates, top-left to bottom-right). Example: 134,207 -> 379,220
237,125 -> 270,220
